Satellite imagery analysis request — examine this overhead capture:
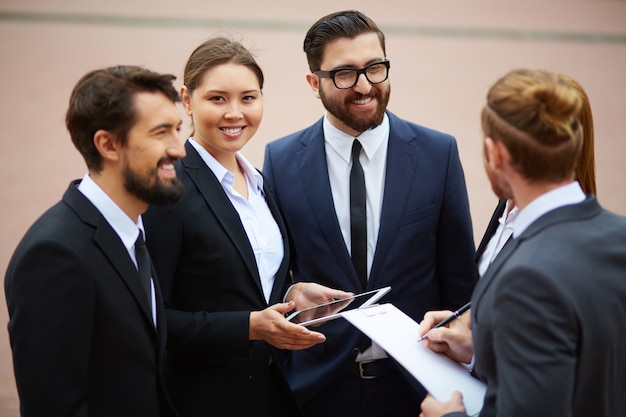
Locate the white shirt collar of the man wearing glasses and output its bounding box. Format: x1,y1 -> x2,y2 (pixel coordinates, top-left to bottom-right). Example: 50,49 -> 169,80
323,113 -> 389,163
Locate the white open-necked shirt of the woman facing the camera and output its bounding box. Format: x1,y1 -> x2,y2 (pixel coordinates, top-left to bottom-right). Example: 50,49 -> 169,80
189,138 -> 285,302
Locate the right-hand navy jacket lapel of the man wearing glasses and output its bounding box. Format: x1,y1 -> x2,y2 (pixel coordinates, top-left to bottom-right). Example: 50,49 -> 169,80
369,113 -> 419,283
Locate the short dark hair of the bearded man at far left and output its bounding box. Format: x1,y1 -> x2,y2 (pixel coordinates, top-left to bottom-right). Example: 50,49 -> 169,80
65,65 -> 180,172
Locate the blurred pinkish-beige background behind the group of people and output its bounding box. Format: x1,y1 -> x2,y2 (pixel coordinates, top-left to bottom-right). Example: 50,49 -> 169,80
0,0 -> 626,417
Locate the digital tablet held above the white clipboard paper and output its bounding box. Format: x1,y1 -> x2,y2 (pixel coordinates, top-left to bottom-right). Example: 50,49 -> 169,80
286,287 -> 391,326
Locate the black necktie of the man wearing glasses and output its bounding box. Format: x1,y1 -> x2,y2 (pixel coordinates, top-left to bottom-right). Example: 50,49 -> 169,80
350,139 -> 367,288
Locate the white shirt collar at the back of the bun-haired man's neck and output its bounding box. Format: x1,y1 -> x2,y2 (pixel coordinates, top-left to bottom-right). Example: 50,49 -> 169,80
513,181 -> 586,238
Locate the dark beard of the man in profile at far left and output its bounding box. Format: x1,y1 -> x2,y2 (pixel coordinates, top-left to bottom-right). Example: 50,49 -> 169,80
122,157 -> 185,206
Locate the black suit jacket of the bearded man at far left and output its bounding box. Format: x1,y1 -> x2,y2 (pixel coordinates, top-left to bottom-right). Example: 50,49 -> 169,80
5,183 -> 174,417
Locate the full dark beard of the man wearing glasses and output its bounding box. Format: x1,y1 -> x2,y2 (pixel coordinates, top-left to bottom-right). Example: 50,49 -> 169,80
319,85 -> 391,133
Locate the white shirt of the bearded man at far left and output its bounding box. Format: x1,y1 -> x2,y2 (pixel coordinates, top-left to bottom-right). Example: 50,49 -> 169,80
78,174 -> 156,326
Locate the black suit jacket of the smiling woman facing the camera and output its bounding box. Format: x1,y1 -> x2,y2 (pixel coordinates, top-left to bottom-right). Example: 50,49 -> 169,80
144,142 -> 290,417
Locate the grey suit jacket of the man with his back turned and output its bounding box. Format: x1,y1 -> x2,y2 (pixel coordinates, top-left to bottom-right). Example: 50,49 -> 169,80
451,197 -> 626,417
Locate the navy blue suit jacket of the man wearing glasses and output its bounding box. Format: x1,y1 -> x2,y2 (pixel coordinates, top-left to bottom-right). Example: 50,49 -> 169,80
263,112 -> 476,406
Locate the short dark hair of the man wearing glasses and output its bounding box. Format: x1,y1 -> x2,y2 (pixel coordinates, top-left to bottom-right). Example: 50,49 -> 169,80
304,10 -> 387,72
